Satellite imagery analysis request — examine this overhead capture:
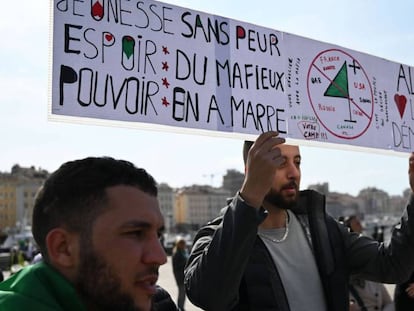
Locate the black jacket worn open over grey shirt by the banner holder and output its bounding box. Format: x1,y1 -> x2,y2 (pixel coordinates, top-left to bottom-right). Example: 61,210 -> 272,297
185,190 -> 414,311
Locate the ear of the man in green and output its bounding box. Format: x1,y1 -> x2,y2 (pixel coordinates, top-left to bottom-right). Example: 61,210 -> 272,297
46,228 -> 79,269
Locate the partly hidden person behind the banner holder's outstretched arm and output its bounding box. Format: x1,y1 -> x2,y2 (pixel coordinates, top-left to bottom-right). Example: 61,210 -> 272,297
345,215 -> 394,311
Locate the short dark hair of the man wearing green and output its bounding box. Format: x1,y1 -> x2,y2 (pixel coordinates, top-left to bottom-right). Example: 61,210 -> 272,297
32,157 -> 158,261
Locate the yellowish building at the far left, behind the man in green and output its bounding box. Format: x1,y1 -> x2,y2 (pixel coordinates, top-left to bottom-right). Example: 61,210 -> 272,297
0,165 -> 49,230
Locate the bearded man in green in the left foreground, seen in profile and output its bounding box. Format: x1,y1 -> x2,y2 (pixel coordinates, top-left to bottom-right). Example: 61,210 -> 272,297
0,157 -> 177,311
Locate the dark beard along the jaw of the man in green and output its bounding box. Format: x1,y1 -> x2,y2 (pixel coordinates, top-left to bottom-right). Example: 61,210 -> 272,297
75,239 -> 139,311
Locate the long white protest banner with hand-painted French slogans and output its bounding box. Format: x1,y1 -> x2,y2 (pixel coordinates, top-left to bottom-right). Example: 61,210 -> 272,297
50,0 -> 414,152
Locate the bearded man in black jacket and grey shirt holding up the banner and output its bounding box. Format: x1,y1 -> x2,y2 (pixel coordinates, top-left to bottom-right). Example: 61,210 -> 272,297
185,131 -> 414,311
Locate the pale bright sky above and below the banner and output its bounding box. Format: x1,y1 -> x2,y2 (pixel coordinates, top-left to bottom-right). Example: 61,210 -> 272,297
0,0 -> 414,196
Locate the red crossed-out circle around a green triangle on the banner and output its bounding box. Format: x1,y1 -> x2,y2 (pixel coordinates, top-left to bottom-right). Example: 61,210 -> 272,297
307,49 -> 374,139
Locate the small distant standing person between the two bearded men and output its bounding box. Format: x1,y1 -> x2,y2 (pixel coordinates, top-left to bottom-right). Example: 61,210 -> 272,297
172,238 -> 188,311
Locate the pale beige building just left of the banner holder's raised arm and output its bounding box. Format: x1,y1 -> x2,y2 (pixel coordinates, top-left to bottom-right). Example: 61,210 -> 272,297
174,185 -> 231,227
